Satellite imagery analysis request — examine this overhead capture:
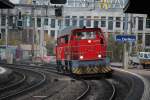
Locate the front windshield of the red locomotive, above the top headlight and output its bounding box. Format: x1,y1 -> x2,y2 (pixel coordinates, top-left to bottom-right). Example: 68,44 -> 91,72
76,32 -> 96,40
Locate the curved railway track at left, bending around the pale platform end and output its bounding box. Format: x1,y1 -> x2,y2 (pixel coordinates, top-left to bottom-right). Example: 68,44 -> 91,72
0,65 -> 46,100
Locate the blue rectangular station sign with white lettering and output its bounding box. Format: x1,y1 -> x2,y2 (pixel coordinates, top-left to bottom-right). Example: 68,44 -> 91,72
116,35 -> 136,42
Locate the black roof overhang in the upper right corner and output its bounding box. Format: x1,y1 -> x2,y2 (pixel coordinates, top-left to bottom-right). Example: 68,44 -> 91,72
123,0 -> 150,14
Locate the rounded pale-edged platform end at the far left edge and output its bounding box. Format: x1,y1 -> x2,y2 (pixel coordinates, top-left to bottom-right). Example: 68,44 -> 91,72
0,67 -> 13,84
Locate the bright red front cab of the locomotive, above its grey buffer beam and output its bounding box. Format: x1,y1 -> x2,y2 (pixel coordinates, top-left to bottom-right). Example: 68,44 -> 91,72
70,29 -> 106,60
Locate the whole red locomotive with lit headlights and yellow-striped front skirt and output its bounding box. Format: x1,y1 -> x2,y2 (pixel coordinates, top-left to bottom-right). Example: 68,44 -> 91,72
55,27 -> 112,75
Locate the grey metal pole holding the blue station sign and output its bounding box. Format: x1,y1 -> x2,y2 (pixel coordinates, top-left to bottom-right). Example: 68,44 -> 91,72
123,13 -> 128,69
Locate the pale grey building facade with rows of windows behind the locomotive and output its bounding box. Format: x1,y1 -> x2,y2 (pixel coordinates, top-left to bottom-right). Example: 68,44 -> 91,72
0,0 -> 150,48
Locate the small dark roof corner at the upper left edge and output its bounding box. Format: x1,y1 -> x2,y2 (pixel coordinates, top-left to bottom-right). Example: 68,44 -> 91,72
0,0 -> 15,9
